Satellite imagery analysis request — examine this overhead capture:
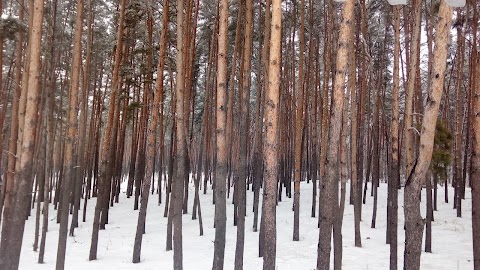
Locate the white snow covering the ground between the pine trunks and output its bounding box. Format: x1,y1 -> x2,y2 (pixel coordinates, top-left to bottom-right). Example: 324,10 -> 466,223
20,178 -> 473,270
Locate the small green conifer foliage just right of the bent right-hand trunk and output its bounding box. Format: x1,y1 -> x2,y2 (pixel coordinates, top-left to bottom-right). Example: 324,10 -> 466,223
430,120 -> 453,175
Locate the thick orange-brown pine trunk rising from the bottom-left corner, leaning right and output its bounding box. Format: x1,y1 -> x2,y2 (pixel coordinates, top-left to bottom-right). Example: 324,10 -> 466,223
0,0 -> 44,270
